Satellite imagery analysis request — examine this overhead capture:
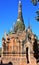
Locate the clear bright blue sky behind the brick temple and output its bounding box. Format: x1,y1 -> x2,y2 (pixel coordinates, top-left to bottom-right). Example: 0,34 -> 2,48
0,0 -> 39,47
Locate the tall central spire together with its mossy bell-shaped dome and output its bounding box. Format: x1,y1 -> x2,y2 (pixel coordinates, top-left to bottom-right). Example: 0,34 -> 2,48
14,1 -> 25,32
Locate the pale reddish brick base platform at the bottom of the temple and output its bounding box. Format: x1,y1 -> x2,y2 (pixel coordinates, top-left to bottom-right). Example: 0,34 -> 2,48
2,54 -> 39,65
